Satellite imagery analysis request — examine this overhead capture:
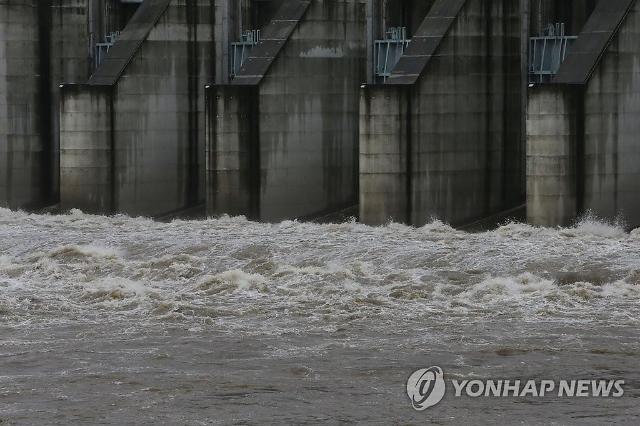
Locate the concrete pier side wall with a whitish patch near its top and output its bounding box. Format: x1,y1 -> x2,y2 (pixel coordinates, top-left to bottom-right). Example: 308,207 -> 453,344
259,0 -> 365,221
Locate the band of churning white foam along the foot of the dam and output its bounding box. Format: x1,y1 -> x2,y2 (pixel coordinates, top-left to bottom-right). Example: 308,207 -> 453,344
0,209 -> 640,331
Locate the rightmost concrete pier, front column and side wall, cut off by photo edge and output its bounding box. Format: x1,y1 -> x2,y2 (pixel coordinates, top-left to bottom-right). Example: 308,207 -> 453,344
527,0 -> 640,227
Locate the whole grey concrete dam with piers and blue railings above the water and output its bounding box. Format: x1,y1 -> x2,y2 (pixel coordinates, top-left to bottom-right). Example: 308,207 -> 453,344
0,0 -> 640,226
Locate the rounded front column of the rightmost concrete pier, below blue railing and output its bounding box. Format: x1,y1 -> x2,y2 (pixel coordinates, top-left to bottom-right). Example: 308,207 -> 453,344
527,85 -> 581,226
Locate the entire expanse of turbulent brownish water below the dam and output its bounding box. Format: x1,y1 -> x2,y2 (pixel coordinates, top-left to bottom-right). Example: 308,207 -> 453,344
0,209 -> 640,424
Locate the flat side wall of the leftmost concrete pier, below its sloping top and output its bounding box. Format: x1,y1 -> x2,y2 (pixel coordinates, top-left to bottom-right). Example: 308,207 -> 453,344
108,0 -> 214,215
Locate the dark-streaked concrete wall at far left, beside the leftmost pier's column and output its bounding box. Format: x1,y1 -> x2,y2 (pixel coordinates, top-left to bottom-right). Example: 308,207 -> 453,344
0,0 -> 90,208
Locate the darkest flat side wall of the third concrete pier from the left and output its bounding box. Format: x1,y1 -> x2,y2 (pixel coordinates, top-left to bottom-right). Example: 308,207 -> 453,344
412,0 -> 524,224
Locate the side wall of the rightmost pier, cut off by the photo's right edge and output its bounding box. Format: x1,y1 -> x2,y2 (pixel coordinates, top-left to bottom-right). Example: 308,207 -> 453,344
584,2 -> 640,227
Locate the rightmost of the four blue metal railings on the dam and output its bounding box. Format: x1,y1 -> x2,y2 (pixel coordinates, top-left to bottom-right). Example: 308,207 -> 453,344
529,24 -> 578,83
